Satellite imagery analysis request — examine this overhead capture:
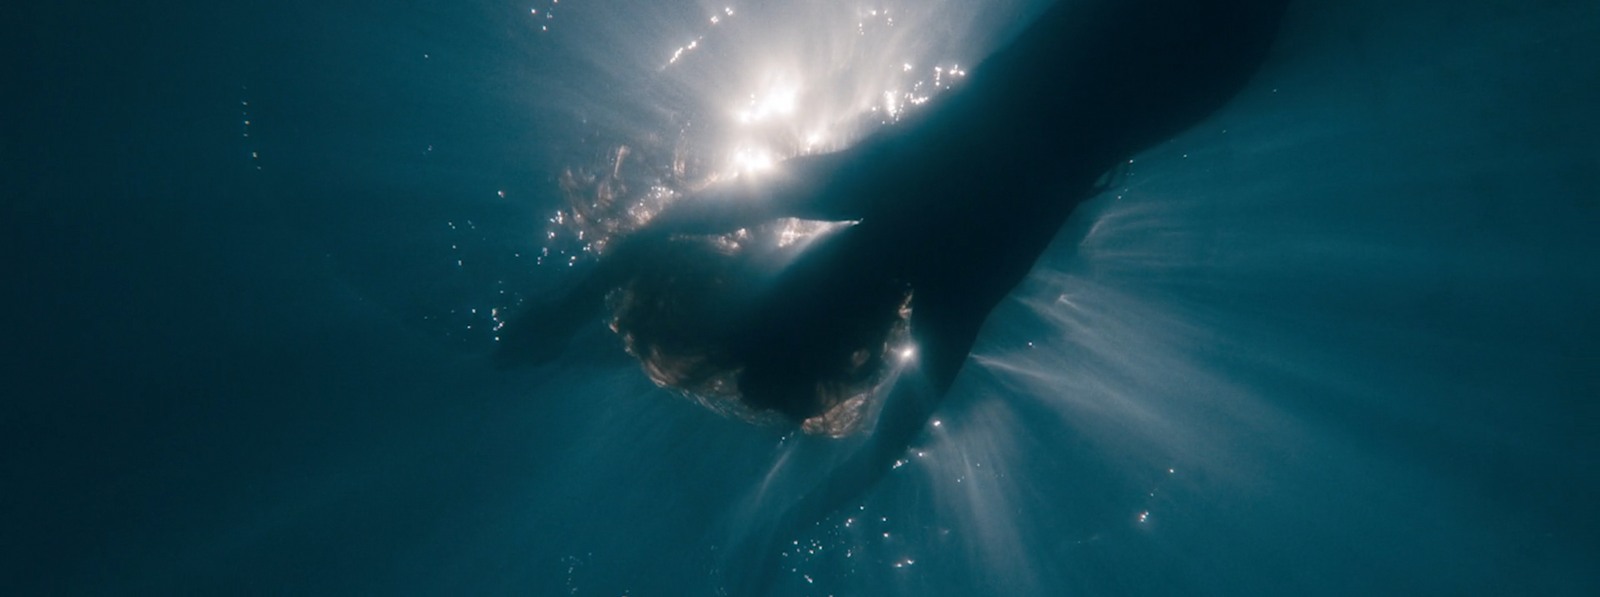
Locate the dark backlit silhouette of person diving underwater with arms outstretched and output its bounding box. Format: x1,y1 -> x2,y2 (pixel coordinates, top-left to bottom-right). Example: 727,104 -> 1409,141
498,0 -> 1286,585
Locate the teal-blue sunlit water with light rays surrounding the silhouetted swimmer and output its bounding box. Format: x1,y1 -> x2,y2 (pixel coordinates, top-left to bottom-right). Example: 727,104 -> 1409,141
0,0 -> 1600,595
